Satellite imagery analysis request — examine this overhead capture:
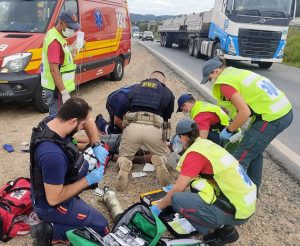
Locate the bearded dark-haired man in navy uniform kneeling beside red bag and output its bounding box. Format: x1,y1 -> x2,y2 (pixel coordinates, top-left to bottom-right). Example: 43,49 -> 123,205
30,98 -> 108,246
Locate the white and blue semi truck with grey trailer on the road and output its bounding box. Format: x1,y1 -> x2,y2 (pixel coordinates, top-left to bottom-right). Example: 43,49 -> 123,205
158,0 -> 297,69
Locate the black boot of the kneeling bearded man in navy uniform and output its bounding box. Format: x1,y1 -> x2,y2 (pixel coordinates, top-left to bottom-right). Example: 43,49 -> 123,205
30,222 -> 53,246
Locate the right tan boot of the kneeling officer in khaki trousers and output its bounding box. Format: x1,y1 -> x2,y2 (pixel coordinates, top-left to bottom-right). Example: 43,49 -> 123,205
151,155 -> 171,186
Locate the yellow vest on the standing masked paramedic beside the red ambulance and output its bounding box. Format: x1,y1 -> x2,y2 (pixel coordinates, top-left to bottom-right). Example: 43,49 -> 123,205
41,27 -> 76,92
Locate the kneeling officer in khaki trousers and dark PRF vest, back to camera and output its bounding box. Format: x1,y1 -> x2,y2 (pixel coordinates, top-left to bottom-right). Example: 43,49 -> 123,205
115,71 -> 175,190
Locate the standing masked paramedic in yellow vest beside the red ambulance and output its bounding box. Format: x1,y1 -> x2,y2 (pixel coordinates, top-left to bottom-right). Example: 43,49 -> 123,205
41,10 -> 80,115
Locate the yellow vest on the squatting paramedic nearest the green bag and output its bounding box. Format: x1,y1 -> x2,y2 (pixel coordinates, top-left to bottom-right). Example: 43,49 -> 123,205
177,138 -> 257,219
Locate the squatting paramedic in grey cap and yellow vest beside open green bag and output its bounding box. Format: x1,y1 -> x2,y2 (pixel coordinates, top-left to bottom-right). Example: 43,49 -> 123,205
150,118 -> 257,245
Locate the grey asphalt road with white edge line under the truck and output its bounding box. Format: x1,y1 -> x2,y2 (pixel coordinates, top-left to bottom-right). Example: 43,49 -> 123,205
138,41 -> 300,180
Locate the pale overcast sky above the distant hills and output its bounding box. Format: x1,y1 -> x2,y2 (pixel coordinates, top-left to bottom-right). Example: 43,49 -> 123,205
127,0 -> 214,15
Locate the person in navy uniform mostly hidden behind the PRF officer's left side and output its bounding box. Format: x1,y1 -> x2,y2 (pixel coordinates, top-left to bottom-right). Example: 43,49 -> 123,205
96,84 -> 136,134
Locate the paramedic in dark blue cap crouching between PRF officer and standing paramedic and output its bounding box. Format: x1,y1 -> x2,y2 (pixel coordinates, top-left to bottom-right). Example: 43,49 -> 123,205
177,93 -> 230,145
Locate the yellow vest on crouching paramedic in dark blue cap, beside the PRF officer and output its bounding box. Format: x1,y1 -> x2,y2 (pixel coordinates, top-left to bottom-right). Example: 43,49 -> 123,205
191,101 -> 230,126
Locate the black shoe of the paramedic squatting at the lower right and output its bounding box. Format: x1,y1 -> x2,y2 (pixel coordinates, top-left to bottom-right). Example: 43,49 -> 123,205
203,226 -> 239,246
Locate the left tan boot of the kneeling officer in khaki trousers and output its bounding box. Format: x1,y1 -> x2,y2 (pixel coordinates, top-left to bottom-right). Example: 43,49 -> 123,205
115,157 -> 133,191
